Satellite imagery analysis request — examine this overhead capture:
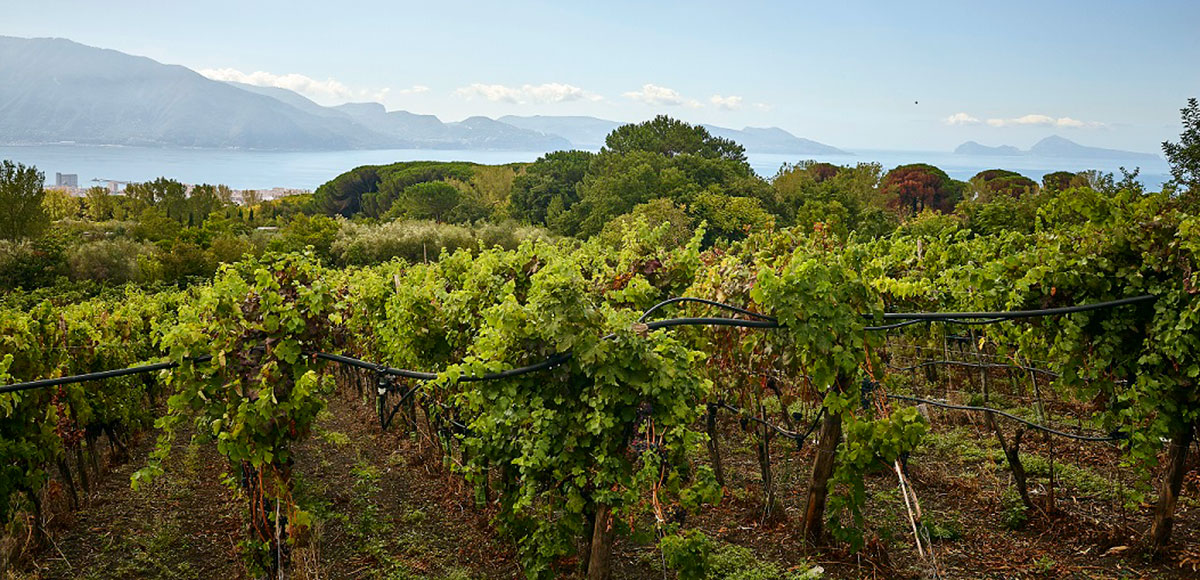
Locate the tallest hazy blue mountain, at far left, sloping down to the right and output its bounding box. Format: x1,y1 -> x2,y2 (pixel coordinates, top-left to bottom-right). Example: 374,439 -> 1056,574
0,36 -> 388,149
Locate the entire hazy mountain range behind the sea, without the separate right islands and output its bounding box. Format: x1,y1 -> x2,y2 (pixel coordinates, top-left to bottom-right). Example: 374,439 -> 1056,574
0,36 -> 845,155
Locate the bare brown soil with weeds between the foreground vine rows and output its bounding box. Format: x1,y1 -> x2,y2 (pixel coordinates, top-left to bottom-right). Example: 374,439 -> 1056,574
16,395 -> 1200,579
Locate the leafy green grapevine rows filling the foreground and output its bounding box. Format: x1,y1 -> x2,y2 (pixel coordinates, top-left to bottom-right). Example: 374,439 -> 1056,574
0,177 -> 1200,579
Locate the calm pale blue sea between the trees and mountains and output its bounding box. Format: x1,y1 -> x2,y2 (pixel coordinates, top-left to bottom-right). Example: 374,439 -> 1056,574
0,144 -> 1170,191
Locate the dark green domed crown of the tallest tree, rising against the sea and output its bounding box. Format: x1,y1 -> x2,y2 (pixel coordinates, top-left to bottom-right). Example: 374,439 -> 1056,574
605,115 -> 749,168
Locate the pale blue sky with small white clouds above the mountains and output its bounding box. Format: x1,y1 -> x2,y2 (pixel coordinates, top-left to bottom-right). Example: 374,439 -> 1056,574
0,0 -> 1200,153
